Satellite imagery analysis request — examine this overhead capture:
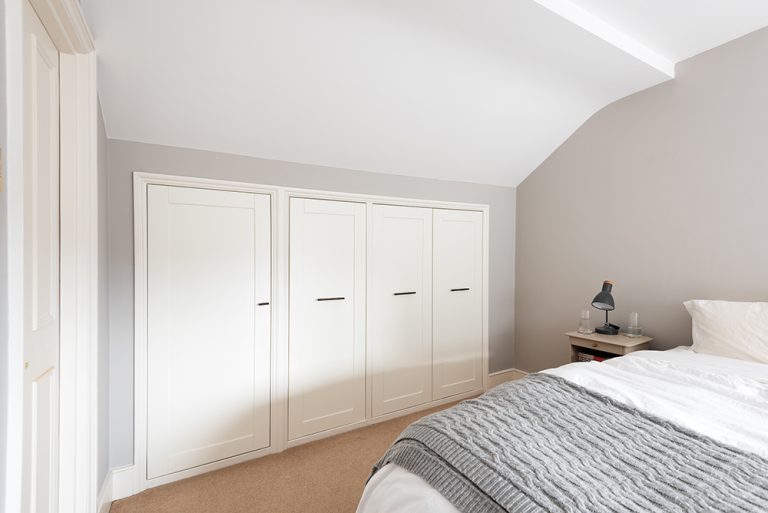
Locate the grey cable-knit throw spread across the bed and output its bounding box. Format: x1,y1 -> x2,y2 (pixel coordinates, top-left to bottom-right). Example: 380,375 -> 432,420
373,374 -> 768,513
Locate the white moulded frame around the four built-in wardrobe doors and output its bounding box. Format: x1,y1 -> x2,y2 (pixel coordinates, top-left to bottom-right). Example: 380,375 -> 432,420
129,170 -> 490,500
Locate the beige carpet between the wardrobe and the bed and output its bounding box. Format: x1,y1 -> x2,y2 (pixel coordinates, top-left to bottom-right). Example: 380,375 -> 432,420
110,404 -> 460,513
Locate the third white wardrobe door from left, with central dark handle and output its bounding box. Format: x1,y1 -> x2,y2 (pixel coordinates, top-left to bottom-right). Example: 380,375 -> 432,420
368,205 -> 432,416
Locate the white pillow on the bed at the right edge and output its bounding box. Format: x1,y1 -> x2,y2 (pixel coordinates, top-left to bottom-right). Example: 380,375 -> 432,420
683,299 -> 768,363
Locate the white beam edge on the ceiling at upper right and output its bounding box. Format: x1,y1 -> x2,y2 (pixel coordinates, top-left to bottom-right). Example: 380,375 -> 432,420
534,0 -> 675,78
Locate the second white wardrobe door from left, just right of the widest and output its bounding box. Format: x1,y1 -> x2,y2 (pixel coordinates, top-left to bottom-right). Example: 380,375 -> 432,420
288,198 -> 366,439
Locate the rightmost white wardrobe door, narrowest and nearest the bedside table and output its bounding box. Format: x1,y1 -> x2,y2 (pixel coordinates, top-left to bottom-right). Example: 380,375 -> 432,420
433,209 -> 483,399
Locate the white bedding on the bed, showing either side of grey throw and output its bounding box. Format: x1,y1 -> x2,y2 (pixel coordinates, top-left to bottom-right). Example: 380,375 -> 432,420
357,347 -> 768,513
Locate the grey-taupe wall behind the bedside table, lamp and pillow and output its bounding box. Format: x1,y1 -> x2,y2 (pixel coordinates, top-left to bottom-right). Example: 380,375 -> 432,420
515,29 -> 768,370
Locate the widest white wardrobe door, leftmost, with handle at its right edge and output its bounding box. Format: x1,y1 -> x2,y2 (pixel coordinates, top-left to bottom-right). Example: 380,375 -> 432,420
147,185 -> 271,479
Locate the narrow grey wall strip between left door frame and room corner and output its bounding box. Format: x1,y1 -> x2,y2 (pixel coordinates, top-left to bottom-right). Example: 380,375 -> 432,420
97,105 -> 109,489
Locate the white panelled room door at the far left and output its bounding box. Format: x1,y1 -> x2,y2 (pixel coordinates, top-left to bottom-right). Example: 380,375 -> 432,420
22,1 -> 59,513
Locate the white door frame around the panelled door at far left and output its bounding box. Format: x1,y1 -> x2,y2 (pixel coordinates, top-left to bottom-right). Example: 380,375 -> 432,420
0,0 -> 98,513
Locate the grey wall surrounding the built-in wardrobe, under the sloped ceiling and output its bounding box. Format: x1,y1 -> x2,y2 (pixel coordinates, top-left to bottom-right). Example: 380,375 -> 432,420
108,141 -> 515,466
